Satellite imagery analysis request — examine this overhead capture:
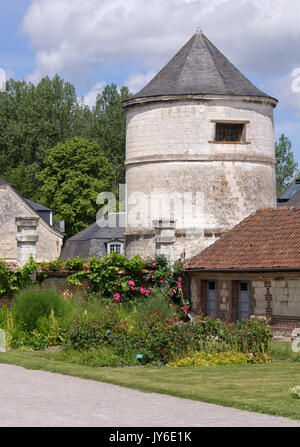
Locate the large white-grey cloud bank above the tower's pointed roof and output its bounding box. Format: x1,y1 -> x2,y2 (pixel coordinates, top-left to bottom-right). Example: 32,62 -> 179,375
23,0 -> 300,89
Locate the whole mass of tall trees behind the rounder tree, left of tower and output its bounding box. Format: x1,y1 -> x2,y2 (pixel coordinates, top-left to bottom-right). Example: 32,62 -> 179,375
0,75 -> 130,203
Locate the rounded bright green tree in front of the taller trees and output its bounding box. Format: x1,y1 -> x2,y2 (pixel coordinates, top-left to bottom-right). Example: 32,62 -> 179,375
37,137 -> 114,236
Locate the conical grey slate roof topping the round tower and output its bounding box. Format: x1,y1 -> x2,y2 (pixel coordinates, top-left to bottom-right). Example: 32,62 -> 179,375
131,31 -> 273,99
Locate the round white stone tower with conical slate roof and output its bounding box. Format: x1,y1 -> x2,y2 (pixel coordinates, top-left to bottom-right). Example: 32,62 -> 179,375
124,31 -> 277,260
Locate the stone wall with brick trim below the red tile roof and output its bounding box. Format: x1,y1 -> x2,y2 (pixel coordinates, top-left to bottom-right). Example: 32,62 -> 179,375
187,272 -> 300,331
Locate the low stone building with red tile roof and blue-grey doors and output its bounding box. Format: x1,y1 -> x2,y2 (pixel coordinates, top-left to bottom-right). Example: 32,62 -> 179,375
184,207 -> 300,327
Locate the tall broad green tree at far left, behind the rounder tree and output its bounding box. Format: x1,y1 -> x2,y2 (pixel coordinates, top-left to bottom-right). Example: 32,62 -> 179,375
0,75 -> 92,199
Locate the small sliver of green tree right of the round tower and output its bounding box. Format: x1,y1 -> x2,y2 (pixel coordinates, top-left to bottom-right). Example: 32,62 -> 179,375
275,134 -> 299,193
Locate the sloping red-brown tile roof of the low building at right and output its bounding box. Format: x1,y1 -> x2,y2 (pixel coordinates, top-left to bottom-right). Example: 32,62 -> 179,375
184,206 -> 300,271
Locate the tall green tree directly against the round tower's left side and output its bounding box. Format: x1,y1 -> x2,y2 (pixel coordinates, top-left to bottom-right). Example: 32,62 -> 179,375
90,84 -> 131,186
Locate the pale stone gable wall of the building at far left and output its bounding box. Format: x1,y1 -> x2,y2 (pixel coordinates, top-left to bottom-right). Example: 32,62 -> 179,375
0,186 -> 63,262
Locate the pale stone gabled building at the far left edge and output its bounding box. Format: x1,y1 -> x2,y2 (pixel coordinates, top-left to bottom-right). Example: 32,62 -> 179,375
0,179 -> 64,266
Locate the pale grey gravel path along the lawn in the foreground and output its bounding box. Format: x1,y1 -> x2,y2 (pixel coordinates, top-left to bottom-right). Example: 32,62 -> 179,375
0,364 -> 300,427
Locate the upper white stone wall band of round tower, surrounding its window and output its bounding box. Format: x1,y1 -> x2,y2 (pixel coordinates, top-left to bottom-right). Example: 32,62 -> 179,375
126,99 -> 274,160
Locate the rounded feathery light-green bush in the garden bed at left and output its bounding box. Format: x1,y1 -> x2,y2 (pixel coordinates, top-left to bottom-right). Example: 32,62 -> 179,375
12,286 -> 72,332
